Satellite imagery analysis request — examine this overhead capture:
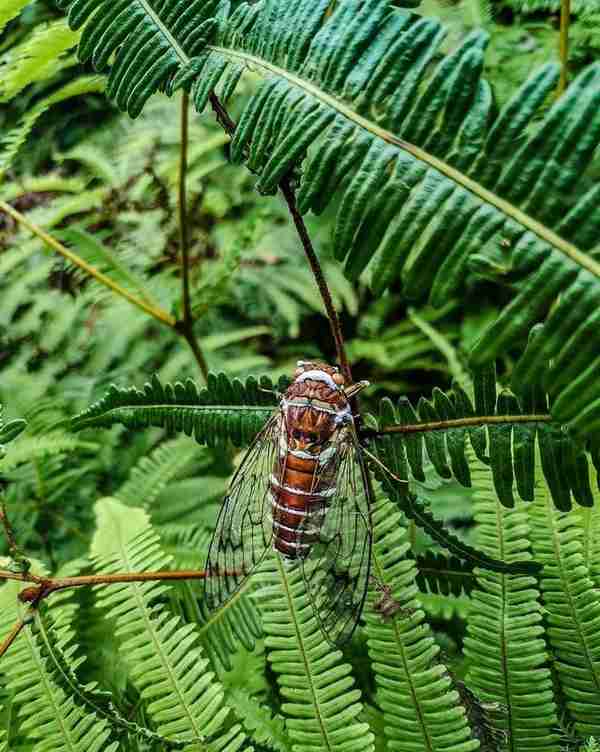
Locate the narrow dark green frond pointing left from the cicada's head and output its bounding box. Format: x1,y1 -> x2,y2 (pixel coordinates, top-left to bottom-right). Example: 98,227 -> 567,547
71,373 -> 275,446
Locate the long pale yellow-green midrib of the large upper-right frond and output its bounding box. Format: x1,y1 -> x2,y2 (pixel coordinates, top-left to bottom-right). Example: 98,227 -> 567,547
207,45 -> 600,279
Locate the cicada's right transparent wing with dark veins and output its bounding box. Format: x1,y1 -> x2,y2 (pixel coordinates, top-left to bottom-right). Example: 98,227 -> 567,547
300,426 -> 372,645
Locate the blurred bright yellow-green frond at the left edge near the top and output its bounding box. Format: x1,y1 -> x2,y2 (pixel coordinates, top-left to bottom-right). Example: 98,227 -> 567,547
0,20 -> 79,102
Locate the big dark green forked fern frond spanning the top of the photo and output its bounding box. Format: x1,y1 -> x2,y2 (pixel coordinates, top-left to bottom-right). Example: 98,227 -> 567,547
56,0 -> 600,434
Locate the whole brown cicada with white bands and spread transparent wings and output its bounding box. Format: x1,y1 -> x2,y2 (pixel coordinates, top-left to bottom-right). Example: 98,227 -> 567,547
205,361 -> 372,645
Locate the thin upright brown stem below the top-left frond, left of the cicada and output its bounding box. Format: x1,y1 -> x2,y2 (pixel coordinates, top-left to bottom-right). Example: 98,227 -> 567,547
177,91 -> 208,381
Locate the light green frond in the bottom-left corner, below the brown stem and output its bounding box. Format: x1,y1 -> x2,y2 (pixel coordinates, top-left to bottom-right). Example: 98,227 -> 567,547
0,583 -> 119,752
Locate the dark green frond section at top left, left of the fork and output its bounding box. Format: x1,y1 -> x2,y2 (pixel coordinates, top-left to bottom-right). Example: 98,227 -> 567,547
58,0 -> 222,117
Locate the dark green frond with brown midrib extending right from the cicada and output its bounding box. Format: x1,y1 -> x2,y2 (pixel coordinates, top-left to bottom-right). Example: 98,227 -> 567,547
374,365 -> 600,510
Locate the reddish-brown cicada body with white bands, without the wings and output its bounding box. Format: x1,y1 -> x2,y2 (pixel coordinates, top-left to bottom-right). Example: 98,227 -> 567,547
271,368 -> 352,559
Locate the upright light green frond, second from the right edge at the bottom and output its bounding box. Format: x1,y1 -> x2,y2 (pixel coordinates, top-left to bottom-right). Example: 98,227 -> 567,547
465,452 -> 559,752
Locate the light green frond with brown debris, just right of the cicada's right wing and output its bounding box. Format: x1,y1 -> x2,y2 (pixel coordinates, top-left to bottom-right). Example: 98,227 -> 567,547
365,500 -> 479,752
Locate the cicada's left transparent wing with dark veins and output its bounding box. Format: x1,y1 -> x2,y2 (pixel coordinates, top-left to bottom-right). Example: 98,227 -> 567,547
204,413 -> 283,609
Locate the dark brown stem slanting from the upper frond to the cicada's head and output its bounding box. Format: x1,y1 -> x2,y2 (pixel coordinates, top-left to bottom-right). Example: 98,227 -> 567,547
210,92 -> 352,384
